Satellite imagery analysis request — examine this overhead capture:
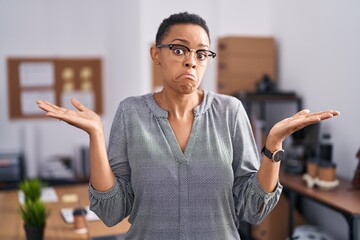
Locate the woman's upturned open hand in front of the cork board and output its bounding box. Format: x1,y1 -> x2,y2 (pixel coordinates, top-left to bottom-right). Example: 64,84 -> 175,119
36,98 -> 102,135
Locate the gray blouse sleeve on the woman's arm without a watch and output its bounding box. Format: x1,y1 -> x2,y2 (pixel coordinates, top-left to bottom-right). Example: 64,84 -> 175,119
89,104 -> 134,226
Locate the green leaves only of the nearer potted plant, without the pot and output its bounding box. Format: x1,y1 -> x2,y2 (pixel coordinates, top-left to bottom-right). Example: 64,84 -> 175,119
20,198 -> 49,227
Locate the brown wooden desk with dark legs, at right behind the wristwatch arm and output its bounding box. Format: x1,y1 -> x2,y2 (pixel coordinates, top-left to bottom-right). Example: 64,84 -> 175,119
280,173 -> 360,240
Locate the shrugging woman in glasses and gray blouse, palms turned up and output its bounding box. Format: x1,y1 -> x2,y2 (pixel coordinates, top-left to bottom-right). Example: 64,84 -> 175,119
37,13 -> 339,240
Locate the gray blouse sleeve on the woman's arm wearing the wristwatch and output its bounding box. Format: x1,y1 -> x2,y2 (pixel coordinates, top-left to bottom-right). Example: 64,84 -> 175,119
233,102 -> 282,224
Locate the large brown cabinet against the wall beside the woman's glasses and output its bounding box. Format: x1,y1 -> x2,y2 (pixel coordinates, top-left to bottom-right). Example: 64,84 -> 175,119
217,36 -> 277,95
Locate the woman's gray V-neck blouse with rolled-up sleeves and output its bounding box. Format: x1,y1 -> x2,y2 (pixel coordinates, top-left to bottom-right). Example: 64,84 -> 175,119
89,91 -> 282,240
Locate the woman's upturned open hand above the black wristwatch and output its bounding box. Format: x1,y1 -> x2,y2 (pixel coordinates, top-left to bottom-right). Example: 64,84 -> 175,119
266,109 -> 340,149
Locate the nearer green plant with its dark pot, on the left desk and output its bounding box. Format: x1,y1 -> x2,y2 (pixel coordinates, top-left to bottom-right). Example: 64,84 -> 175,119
20,198 -> 49,240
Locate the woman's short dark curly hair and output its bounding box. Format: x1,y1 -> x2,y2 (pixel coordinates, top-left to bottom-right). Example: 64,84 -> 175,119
155,12 -> 210,45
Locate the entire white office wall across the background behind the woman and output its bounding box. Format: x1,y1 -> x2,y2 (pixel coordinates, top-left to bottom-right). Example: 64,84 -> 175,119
0,0 -> 360,239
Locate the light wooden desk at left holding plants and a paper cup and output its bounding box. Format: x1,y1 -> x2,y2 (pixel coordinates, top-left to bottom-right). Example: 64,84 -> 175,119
0,184 -> 130,240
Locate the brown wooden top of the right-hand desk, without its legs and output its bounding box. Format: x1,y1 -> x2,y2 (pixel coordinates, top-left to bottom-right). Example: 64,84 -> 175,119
280,173 -> 360,215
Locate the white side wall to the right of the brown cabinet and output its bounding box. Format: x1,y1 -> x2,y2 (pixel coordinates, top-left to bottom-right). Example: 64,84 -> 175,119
270,0 -> 360,239
